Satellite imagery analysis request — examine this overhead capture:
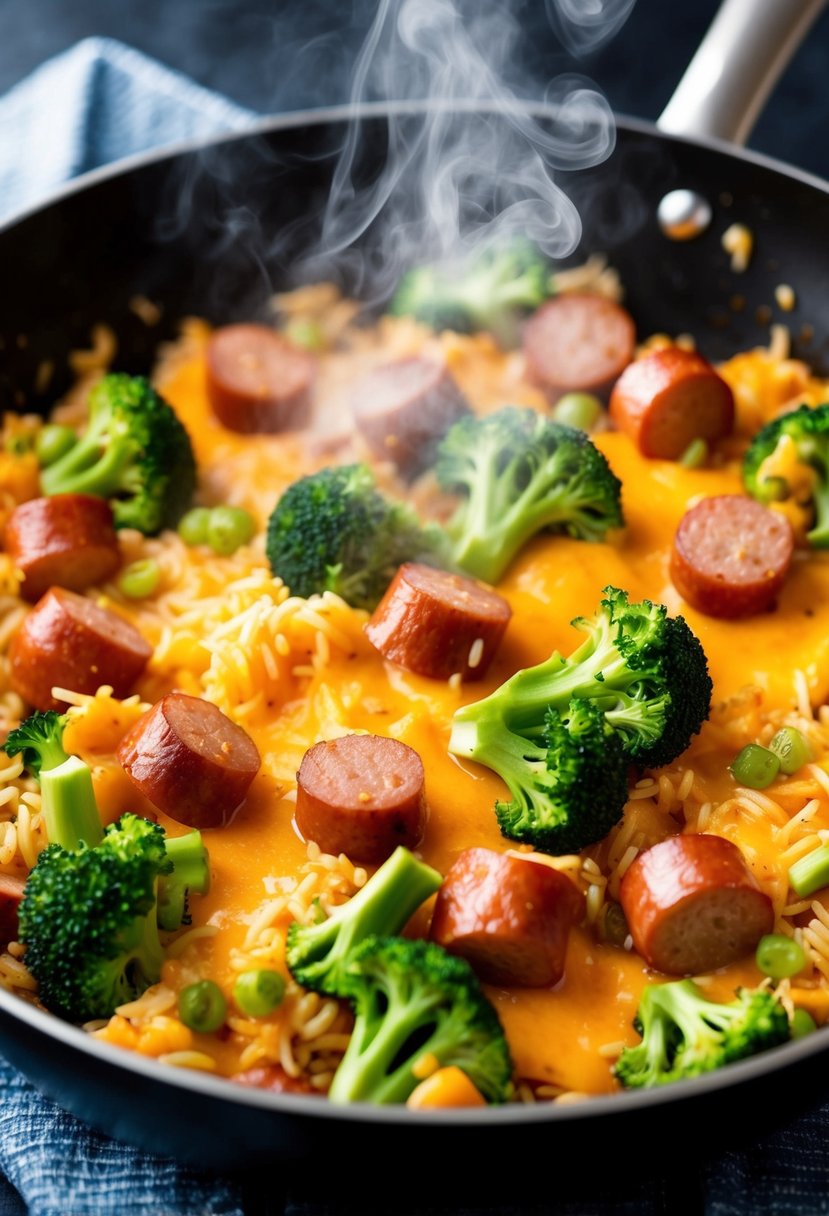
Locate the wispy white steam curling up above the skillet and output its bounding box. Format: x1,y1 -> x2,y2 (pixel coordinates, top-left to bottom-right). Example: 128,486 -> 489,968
306,0 -> 619,299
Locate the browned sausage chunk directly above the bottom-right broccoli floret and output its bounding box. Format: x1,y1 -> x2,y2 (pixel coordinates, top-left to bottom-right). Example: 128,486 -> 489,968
619,835 -> 774,975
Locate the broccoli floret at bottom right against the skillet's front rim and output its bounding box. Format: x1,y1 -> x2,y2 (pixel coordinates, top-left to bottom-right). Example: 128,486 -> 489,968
614,980 -> 791,1090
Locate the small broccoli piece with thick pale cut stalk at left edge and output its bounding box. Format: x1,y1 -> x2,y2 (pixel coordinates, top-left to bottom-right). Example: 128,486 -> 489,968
4,709 -> 103,850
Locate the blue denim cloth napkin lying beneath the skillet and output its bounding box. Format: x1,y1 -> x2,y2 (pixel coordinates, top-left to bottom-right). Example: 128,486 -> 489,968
0,28 -> 829,1216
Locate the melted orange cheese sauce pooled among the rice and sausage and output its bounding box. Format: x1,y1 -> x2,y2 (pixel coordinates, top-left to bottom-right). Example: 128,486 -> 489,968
16,308 -> 829,1093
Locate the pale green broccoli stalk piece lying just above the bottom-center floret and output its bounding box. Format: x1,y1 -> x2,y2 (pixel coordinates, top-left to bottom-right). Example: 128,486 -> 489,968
287,845 -> 442,996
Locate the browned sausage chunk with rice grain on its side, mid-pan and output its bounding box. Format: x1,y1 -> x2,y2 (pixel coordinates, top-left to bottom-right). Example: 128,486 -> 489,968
366,562 -> 512,680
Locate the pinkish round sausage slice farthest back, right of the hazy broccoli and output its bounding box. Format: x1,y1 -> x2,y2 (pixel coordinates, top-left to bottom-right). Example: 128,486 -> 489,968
524,292 -> 636,405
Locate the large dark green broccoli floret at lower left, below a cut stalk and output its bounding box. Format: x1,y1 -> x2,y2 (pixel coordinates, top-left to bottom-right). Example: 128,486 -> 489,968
19,815 -> 170,1021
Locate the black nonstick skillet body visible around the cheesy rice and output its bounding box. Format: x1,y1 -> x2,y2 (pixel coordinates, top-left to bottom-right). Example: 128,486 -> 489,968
0,4 -> 829,1169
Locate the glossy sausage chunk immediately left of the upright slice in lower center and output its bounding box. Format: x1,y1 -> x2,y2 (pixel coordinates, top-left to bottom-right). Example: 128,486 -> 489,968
117,692 -> 260,828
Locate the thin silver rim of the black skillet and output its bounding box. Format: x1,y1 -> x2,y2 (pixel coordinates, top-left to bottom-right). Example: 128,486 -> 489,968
0,98 -> 829,1130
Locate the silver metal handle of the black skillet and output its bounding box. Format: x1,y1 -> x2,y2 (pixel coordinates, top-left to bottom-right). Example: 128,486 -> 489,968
656,0 -> 825,146
